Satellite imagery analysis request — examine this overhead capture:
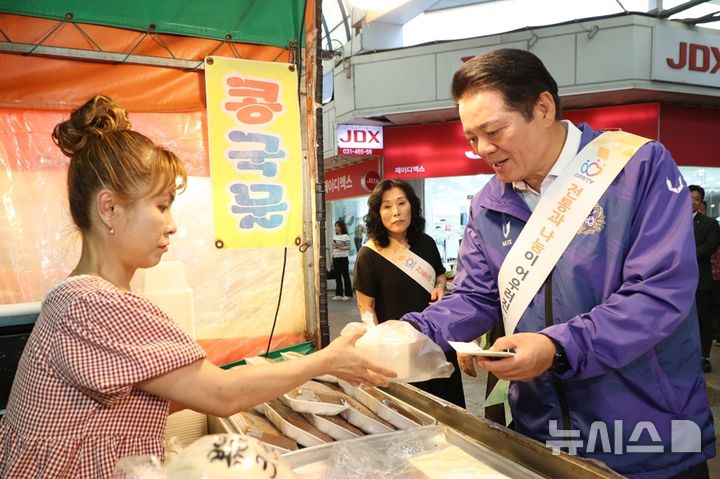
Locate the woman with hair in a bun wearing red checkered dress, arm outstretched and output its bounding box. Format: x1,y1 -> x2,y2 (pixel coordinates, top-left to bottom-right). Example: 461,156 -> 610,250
0,95 -> 394,479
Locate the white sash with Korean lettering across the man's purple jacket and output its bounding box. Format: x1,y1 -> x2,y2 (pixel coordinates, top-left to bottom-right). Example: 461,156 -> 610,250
498,131 -> 651,334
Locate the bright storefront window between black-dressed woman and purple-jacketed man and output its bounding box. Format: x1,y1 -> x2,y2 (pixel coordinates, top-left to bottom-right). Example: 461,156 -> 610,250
423,175 -> 493,269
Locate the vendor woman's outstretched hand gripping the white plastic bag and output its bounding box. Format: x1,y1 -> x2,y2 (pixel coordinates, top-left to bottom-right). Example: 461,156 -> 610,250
323,328 -> 397,386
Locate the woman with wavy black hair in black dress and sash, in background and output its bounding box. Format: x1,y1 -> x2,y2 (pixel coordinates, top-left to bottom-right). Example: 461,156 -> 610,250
354,179 -> 465,408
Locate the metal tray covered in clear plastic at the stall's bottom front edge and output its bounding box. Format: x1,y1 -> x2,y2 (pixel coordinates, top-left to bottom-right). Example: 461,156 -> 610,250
283,426 -> 542,479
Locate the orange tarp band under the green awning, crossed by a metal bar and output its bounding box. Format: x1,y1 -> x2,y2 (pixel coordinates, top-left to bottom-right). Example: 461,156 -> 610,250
0,14 -> 290,112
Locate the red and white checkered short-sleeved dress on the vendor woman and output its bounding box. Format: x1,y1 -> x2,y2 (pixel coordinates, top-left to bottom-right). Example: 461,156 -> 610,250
0,276 -> 205,479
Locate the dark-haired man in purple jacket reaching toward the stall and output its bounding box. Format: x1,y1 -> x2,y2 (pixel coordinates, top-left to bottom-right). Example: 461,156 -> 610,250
402,49 -> 715,479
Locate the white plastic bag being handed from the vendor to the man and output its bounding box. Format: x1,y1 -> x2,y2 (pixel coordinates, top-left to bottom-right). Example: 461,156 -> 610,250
340,320 -> 455,383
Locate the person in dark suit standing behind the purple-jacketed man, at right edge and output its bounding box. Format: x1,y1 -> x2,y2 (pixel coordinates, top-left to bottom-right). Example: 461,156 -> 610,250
688,185 -> 720,373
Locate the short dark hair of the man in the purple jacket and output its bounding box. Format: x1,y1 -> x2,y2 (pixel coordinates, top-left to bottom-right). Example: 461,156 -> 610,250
451,48 -> 562,121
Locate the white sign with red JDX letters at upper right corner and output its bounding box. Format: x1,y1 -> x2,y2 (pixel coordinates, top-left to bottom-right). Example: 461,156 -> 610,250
652,26 -> 720,87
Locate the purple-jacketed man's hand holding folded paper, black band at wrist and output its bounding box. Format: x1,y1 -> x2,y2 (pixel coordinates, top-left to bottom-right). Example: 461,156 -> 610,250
478,333 -> 555,381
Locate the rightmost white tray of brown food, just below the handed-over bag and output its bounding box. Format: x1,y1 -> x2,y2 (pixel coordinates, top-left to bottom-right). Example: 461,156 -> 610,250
342,383 -> 436,429
